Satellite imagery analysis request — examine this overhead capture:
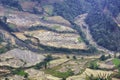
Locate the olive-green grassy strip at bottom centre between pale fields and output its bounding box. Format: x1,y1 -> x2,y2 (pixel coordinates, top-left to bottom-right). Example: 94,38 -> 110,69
45,69 -> 74,79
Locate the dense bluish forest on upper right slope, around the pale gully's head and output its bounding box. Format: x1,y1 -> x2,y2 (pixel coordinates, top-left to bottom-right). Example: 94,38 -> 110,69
54,0 -> 120,51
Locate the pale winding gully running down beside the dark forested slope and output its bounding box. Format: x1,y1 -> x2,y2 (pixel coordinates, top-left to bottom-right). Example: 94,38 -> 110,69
75,13 -> 114,54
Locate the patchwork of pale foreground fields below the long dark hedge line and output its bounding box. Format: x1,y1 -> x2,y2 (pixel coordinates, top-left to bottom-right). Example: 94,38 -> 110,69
0,49 -> 117,80
